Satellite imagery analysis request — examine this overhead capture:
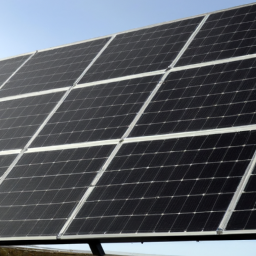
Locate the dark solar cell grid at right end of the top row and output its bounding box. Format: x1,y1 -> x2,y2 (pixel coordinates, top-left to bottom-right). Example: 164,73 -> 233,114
176,5 -> 256,66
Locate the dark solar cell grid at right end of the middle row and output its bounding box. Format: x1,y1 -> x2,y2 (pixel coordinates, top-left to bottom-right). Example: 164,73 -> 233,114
130,59 -> 256,137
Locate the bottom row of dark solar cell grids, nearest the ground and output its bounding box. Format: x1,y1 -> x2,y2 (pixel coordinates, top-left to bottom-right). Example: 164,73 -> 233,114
0,131 -> 256,236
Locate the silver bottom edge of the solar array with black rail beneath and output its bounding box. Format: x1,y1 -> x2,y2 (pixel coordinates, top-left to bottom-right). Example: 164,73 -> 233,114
0,229 -> 256,245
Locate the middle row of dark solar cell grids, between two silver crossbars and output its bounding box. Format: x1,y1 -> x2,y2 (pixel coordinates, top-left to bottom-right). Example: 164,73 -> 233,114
0,58 -> 256,150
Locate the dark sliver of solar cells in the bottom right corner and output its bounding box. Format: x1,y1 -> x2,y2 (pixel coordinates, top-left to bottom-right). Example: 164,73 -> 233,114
227,167 -> 256,230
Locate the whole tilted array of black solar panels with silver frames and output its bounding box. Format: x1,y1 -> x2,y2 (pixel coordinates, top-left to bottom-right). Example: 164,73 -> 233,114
0,4 -> 256,242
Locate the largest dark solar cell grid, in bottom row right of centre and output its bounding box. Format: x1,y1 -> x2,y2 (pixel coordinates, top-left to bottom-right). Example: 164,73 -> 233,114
66,132 -> 256,235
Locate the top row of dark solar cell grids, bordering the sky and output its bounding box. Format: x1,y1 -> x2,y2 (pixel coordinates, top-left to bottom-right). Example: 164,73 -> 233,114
0,5 -> 256,97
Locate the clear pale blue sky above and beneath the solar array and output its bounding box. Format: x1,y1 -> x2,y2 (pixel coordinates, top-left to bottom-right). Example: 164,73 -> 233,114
0,0 -> 256,256
